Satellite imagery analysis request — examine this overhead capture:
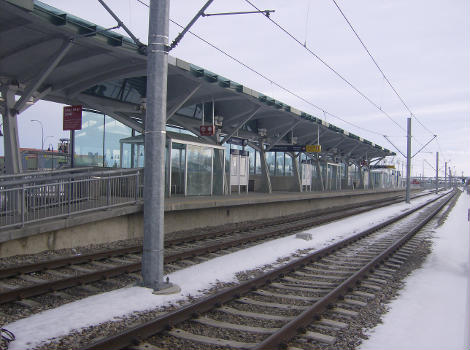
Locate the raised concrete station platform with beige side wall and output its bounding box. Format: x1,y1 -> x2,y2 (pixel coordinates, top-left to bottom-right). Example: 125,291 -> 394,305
0,189 -> 410,257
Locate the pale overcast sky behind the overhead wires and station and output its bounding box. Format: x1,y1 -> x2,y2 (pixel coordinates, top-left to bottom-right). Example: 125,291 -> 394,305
4,0 -> 470,176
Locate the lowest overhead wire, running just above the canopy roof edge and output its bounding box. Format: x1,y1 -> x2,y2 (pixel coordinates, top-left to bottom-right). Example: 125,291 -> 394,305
137,0 -> 383,136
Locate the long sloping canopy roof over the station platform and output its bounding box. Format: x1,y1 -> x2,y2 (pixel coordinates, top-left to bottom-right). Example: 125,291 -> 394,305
0,0 -> 395,162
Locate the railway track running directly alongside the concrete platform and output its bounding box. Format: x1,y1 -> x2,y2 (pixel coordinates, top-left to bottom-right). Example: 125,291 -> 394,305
0,191 -> 430,318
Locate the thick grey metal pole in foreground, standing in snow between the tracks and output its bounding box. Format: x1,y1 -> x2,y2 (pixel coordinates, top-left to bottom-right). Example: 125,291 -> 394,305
142,0 -> 170,290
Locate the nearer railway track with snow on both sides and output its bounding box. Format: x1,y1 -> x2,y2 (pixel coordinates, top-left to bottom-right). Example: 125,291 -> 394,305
76,193 -> 455,350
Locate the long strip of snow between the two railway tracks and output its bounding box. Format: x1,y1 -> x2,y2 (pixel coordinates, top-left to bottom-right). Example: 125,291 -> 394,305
3,195 -> 450,350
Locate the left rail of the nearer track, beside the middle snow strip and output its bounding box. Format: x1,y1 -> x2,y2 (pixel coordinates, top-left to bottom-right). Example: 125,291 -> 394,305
80,190 -> 450,350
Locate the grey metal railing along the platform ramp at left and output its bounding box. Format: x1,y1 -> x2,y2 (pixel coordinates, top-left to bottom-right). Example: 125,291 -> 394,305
0,168 -> 143,229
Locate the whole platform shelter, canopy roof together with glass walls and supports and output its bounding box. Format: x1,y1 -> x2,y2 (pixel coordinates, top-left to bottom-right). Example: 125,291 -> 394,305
0,0 -> 394,196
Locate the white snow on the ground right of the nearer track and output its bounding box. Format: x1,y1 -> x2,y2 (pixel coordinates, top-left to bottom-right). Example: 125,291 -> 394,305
359,193 -> 470,350
